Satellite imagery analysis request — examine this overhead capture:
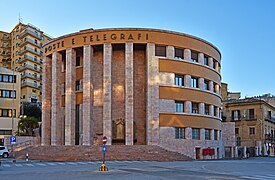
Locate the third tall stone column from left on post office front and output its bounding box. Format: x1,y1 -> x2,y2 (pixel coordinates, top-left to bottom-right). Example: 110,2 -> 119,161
65,48 -> 76,145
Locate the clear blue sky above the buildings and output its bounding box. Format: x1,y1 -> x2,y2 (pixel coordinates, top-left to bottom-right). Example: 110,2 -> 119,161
0,0 -> 275,97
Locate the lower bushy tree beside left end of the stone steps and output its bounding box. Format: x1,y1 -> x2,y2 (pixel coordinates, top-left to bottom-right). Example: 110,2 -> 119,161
18,117 -> 39,136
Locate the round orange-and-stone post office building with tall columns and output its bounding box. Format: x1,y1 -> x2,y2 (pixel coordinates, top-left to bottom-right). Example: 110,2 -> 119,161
42,28 -> 222,159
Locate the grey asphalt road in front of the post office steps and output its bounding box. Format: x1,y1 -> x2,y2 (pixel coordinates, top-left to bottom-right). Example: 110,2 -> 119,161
0,158 -> 275,180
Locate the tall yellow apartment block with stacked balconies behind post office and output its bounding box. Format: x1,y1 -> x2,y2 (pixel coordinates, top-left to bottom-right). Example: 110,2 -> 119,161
0,23 -> 50,102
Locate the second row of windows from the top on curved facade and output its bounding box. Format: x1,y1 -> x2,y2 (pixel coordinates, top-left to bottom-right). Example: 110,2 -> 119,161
174,74 -> 221,94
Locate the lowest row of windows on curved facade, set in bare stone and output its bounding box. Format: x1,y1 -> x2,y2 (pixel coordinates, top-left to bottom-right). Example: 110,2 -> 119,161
175,127 -> 218,140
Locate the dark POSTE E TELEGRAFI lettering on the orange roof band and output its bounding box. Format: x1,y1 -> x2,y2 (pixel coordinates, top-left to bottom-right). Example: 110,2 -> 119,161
44,33 -> 149,53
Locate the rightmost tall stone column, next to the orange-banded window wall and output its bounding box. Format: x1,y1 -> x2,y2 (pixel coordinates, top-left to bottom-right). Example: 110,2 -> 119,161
146,43 -> 159,145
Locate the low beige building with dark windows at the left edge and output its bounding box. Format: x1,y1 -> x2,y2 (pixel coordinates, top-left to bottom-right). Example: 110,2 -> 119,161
0,67 -> 20,145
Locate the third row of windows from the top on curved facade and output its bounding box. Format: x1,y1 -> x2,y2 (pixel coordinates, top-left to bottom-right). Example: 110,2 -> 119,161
178,101 -> 221,117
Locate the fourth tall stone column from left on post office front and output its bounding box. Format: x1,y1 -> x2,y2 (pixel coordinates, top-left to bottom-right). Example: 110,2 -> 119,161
82,45 -> 94,146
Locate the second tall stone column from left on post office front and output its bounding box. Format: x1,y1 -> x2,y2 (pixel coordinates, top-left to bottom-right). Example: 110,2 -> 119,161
51,52 -> 62,146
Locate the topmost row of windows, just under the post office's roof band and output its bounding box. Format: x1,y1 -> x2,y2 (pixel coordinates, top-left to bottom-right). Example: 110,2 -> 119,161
155,45 -> 220,69
